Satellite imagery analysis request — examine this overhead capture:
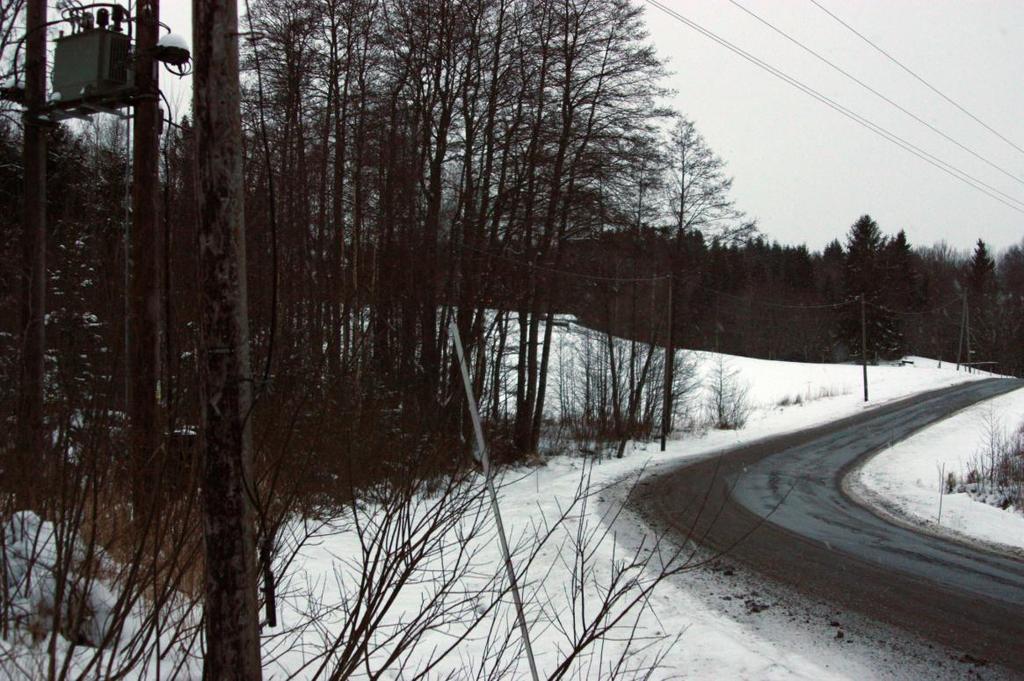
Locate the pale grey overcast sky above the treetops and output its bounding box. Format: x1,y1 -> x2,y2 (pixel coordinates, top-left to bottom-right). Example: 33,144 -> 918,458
162,0 -> 1024,250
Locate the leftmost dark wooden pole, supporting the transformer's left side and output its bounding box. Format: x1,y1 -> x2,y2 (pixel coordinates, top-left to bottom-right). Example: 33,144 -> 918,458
16,0 -> 48,488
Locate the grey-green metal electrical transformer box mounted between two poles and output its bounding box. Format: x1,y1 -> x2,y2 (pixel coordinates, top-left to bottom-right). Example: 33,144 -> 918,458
51,28 -> 133,108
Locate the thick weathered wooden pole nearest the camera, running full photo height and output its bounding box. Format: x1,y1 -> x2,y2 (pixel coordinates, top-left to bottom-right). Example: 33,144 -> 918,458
193,0 -> 260,681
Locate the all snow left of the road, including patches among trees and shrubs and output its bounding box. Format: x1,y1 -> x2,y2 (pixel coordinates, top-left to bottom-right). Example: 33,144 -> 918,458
0,315 -> 982,679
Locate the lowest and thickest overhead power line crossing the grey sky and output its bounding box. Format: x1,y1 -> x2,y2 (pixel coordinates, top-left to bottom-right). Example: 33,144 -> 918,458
646,0 -> 1024,214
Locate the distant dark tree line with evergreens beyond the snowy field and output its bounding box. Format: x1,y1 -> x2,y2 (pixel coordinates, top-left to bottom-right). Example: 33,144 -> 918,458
568,215 -> 1024,376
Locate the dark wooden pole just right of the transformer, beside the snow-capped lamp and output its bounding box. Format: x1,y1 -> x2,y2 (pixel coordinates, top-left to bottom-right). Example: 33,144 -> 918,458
127,0 -> 161,501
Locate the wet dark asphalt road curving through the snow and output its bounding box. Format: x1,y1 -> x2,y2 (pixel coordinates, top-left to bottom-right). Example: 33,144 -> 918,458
633,379 -> 1024,676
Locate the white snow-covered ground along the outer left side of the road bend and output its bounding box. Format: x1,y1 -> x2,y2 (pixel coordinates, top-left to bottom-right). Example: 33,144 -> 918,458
8,332 -> 1003,679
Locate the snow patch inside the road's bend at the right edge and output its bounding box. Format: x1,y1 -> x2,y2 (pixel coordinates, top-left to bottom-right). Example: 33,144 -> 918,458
859,382 -> 1024,549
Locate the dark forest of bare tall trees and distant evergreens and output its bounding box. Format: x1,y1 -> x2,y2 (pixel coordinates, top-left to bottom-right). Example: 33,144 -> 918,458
0,0 -> 1024,671
